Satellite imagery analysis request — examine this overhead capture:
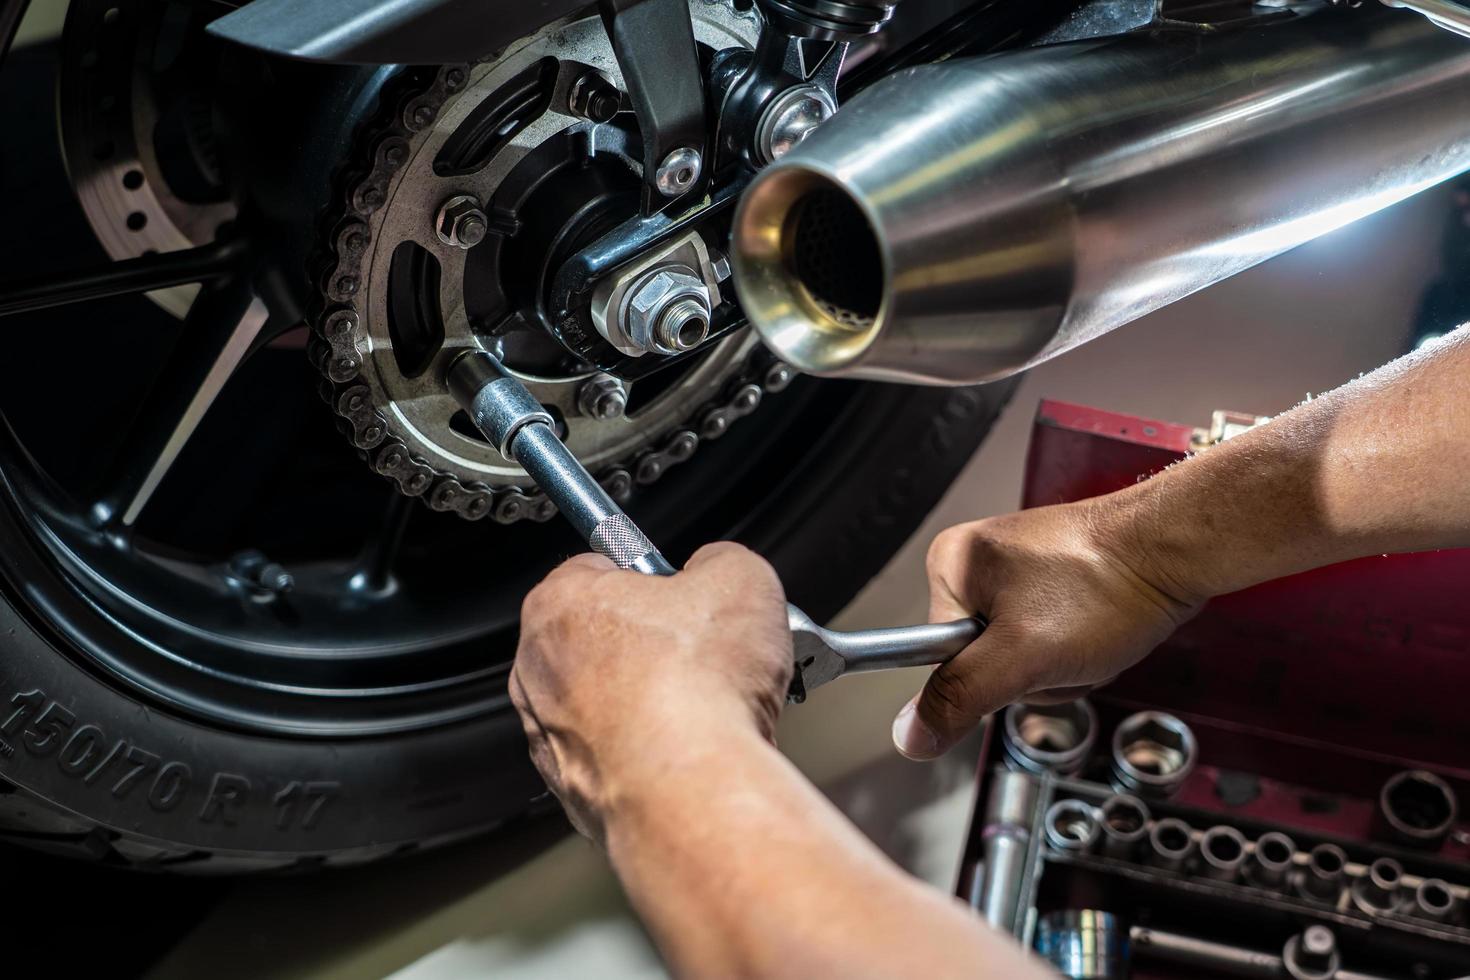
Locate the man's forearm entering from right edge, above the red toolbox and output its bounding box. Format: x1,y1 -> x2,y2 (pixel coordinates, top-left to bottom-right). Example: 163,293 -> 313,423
1101,331 -> 1470,601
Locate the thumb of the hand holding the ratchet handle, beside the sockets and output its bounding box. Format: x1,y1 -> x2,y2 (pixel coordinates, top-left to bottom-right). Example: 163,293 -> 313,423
892,623 -> 1028,761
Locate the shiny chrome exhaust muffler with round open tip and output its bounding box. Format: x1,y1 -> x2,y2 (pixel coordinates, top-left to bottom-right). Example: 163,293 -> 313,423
732,10 -> 1470,385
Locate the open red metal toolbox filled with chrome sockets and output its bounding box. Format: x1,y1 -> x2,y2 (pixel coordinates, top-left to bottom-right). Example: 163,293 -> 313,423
958,401 -> 1470,980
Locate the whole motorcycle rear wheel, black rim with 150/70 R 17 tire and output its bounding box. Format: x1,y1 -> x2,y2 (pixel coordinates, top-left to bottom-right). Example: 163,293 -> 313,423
0,1 -> 1011,873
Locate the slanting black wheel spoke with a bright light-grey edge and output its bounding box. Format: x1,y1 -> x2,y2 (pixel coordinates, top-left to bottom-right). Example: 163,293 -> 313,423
93,281 -> 268,527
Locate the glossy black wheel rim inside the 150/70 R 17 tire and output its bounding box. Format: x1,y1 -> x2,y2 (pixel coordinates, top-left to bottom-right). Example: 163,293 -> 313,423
0,0 -> 817,736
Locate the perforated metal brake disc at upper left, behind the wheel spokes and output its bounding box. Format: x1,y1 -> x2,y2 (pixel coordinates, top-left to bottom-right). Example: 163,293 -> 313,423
57,0 -> 235,317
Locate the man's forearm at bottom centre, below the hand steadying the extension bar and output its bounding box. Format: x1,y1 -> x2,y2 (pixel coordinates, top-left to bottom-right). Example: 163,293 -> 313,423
607,727 -> 1045,979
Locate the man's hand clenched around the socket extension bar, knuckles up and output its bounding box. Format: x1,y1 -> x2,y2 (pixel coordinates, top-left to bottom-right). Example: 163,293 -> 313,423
510,544 -> 792,840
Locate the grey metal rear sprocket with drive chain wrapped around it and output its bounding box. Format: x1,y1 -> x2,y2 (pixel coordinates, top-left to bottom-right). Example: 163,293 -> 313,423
312,0 -> 791,523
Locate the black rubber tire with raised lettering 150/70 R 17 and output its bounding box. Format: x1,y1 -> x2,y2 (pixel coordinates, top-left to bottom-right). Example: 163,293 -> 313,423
0,382 -> 1013,873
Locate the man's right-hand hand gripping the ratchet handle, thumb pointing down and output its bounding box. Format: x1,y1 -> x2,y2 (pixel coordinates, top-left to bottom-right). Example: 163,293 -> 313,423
894,497 -> 1200,760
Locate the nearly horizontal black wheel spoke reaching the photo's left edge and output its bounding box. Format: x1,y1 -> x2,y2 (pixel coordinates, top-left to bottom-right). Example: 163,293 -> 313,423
0,241 -> 245,316
